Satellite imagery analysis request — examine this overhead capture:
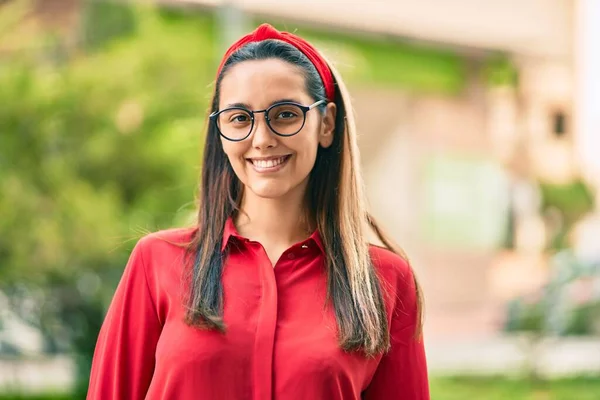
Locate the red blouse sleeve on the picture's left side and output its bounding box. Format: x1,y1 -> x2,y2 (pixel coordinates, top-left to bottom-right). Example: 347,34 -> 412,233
87,239 -> 162,400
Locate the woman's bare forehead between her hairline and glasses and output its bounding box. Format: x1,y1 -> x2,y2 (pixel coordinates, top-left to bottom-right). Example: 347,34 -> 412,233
219,59 -> 310,109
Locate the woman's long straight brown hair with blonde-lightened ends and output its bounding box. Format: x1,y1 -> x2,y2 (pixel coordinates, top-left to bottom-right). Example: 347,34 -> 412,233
186,40 -> 422,355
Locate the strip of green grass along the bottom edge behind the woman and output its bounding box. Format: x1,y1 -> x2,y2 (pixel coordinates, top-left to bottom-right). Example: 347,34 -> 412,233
0,376 -> 600,400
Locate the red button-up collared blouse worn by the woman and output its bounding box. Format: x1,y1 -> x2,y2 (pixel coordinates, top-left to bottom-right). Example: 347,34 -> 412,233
87,220 -> 429,400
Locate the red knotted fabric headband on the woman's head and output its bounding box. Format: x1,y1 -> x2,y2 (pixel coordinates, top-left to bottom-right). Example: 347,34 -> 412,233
217,24 -> 335,101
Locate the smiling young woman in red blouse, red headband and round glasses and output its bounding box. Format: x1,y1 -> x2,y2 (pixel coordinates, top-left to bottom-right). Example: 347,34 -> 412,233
87,24 -> 429,400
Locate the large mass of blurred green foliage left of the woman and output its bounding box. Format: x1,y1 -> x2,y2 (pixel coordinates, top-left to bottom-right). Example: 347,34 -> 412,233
0,3 -> 214,393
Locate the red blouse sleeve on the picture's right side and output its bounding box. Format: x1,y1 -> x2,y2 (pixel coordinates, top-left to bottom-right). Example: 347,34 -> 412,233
362,268 -> 430,400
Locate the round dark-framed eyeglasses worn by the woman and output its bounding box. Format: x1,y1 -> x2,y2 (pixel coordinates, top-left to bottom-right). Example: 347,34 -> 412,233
209,100 -> 325,142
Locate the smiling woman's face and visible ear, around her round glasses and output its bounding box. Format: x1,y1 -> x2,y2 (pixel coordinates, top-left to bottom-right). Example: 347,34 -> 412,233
219,59 -> 335,202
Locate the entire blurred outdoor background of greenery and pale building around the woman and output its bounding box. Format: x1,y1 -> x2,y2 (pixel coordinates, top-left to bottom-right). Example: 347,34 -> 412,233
0,0 -> 600,400
